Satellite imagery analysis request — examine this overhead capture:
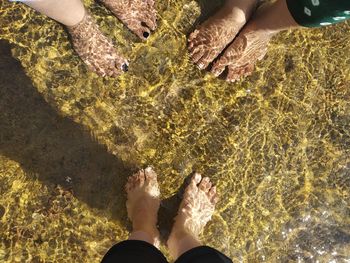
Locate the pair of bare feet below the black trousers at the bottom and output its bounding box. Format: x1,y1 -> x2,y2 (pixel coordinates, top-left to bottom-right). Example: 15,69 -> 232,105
125,167 -> 218,259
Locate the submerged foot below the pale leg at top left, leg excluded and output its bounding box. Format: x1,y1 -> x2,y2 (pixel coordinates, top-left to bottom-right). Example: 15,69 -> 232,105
67,11 -> 128,77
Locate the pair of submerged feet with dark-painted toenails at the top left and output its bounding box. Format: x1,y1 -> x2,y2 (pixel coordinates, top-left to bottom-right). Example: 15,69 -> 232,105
67,0 -> 157,77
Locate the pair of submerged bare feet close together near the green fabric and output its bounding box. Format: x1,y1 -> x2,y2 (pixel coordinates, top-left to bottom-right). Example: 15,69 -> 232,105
189,0 -> 273,82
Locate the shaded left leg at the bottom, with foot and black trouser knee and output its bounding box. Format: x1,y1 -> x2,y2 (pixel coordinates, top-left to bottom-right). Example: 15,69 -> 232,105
102,168 -> 167,263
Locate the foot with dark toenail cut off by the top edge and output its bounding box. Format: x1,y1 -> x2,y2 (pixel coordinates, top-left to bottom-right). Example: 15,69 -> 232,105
100,0 -> 157,40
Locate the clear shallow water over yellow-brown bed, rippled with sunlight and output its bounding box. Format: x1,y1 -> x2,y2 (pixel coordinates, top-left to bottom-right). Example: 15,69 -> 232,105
0,0 -> 350,262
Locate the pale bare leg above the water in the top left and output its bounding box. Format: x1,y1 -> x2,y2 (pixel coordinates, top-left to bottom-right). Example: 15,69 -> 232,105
24,0 -> 85,26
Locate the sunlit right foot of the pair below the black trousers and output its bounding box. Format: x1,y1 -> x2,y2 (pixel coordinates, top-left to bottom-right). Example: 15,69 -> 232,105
168,173 -> 218,244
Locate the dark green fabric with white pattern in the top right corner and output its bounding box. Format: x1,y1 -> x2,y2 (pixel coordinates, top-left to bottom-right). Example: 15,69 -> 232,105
286,0 -> 350,27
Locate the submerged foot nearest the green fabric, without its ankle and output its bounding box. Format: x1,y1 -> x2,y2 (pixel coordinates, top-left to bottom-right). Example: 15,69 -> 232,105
211,3 -> 275,82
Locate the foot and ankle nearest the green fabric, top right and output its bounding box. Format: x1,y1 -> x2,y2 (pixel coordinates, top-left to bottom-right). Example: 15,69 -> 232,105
211,0 -> 299,82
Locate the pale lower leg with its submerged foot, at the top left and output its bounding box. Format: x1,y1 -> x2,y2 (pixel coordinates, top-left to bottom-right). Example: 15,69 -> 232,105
21,0 -> 128,77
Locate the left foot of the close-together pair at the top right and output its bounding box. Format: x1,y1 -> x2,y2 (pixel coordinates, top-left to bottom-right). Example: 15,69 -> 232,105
189,0 -> 257,69
